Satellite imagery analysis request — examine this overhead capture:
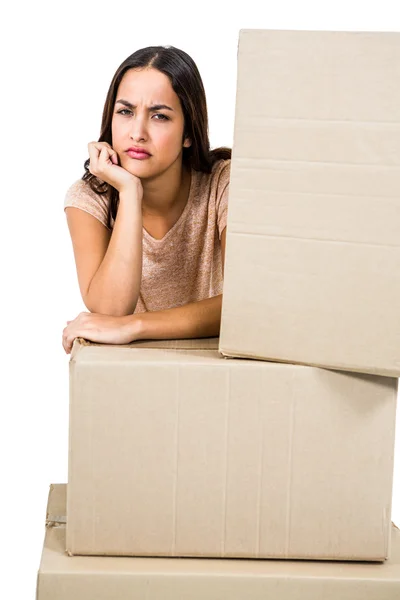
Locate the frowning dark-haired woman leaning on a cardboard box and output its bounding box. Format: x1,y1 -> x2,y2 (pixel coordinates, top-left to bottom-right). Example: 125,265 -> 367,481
63,46 -> 231,354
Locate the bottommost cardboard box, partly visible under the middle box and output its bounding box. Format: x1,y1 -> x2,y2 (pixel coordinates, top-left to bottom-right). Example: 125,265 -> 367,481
36,484 -> 400,600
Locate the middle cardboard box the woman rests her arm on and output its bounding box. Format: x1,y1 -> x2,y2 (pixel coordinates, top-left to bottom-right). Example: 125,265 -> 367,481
67,338 -> 397,561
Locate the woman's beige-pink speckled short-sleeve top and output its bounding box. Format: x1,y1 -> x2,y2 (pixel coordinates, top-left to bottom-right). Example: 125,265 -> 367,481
64,159 -> 231,313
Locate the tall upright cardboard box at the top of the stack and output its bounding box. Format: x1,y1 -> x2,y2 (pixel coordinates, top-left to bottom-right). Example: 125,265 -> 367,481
219,29 -> 400,377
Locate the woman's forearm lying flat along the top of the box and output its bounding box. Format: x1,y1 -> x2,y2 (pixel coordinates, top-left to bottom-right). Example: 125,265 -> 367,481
132,294 -> 222,340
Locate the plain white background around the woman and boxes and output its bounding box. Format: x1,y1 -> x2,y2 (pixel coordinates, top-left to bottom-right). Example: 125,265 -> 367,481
0,0 -> 400,600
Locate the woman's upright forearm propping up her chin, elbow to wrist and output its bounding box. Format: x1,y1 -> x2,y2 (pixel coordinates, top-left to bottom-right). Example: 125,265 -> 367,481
84,188 -> 143,316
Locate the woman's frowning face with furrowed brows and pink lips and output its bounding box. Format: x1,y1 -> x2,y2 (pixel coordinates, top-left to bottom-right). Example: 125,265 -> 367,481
111,68 -> 191,178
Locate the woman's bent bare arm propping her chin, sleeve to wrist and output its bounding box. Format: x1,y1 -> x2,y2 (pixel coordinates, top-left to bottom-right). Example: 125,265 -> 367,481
65,186 -> 143,316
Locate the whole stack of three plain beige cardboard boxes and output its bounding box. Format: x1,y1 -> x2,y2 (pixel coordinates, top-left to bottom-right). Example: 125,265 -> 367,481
37,30 -> 400,600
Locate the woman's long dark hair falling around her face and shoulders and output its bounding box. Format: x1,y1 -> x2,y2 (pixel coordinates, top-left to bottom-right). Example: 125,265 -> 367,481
82,46 -> 232,228
